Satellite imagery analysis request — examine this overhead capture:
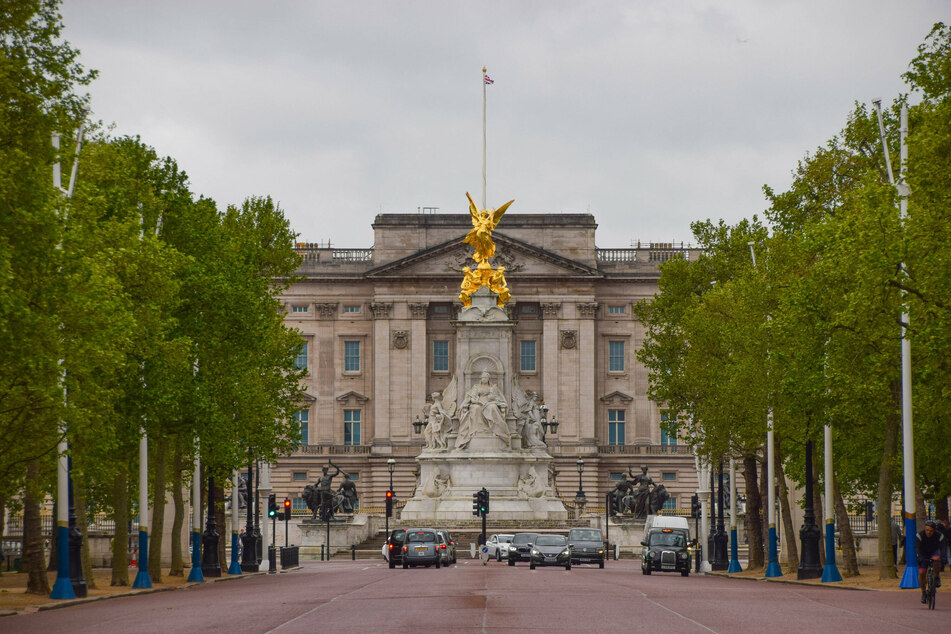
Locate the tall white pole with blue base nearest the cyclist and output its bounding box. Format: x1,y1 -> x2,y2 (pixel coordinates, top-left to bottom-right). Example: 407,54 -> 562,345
872,99 -> 919,588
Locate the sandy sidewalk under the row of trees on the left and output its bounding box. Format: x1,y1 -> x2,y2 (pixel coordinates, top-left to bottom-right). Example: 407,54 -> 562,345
0,568 -> 278,616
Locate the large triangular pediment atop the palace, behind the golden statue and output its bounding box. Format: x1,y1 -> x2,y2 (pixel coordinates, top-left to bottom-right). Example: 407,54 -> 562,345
367,232 -> 601,280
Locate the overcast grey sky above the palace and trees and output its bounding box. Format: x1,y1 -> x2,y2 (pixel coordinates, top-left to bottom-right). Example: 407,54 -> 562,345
62,0 -> 951,247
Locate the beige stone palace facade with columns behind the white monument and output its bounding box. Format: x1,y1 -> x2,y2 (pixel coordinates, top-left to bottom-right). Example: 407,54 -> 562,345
271,213 -> 697,510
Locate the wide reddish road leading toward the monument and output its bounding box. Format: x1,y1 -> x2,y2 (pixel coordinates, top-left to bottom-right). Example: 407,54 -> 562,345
0,560 -> 951,634
